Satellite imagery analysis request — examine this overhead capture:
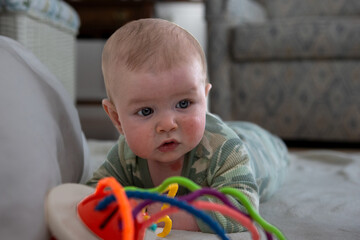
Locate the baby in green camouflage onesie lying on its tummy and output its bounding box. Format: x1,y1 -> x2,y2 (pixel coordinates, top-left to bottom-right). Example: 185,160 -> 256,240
88,19 -> 287,232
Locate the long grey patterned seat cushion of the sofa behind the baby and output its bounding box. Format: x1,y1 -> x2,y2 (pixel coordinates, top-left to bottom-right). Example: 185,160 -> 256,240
232,17 -> 360,61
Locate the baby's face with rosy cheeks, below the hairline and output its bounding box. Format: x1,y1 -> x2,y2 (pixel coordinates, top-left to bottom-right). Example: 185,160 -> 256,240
112,59 -> 210,163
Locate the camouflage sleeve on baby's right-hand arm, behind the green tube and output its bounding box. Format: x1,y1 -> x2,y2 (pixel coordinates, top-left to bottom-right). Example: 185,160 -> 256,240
197,139 -> 259,233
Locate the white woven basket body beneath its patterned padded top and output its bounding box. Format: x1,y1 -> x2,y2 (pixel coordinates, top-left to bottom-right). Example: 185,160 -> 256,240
0,12 -> 76,101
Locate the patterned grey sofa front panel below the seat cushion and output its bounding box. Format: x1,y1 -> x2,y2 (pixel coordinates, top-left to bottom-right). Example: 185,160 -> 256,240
231,59 -> 360,143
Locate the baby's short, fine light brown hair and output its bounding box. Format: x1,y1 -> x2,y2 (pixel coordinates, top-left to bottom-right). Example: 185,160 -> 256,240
102,18 -> 207,100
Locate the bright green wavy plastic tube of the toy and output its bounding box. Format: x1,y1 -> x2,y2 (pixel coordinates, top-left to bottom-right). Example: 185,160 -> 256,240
125,176 -> 286,240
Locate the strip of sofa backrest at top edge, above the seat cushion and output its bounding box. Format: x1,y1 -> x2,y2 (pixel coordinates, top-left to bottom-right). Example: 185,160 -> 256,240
264,0 -> 360,18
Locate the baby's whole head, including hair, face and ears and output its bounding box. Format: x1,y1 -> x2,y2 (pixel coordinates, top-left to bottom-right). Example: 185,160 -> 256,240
102,19 -> 211,163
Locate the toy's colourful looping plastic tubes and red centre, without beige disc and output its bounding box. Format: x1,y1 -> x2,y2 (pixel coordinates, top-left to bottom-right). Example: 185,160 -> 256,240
77,177 -> 286,240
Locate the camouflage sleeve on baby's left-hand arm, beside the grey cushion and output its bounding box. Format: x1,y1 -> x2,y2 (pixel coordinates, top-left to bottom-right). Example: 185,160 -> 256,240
86,144 -> 131,187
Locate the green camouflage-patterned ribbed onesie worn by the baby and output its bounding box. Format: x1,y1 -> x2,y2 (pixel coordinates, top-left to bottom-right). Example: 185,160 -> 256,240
88,113 -> 288,233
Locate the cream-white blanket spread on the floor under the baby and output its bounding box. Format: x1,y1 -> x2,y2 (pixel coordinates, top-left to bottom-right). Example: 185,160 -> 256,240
88,140 -> 360,240
